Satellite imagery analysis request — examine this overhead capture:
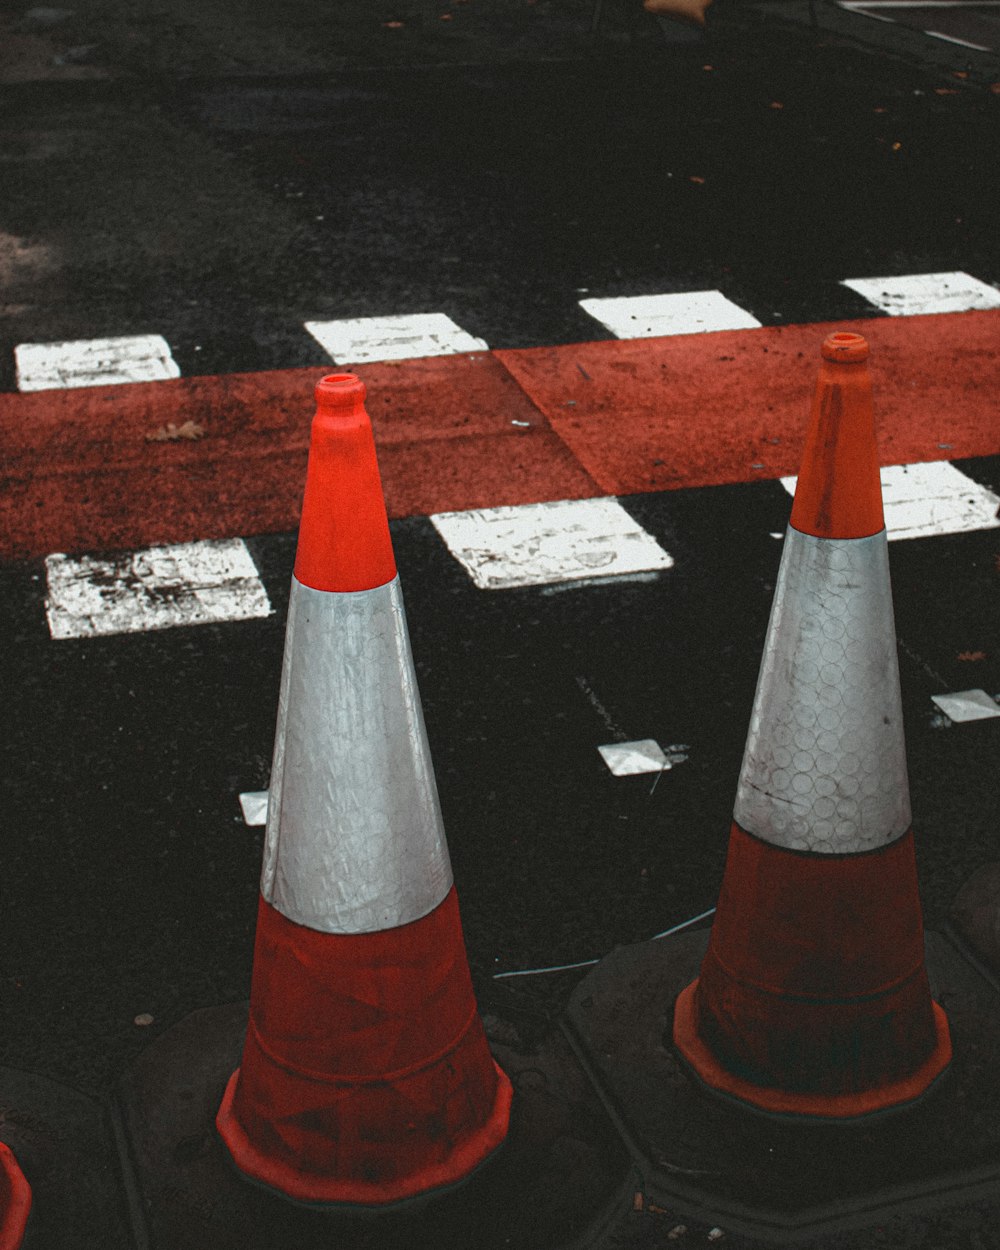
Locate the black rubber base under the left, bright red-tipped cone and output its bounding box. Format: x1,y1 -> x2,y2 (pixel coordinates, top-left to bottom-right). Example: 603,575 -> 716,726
115,1004 -> 635,1250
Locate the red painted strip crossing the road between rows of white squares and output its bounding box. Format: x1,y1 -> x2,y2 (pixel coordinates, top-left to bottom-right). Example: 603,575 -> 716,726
0,310 -> 1000,559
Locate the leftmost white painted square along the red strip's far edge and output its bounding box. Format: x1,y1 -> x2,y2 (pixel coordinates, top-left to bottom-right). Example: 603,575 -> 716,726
14,334 -> 180,391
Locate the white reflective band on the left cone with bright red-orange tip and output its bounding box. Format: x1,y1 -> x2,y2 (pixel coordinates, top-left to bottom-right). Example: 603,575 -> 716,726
261,578 -> 451,934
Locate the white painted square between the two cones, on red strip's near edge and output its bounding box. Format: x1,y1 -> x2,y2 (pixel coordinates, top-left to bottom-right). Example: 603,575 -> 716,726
430,498 -> 674,590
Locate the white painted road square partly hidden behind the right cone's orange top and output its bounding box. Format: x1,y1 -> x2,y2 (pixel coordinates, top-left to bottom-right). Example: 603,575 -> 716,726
781,460 -> 1000,541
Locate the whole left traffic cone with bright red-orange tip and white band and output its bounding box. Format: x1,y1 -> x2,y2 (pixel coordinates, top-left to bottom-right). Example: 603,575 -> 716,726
216,374 -> 511,1208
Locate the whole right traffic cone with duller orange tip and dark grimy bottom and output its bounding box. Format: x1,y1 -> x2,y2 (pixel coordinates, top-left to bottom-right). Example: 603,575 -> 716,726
674,334 -> 951,1120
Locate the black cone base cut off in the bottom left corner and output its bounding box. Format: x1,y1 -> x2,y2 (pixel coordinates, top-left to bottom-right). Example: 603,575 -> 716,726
0,1068 -> 133,1250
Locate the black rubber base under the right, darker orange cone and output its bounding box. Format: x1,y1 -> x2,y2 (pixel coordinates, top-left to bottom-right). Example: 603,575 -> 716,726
565,931 -> 1000,1244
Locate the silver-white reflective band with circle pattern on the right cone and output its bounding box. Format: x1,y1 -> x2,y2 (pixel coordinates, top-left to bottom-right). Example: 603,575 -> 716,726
734,528 -> 910,854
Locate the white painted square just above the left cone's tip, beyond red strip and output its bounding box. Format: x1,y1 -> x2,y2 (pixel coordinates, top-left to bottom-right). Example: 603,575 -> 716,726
305,313 -> 489,365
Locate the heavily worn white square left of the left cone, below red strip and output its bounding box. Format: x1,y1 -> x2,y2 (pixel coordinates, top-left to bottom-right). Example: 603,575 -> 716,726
45,539 -> 271,639
